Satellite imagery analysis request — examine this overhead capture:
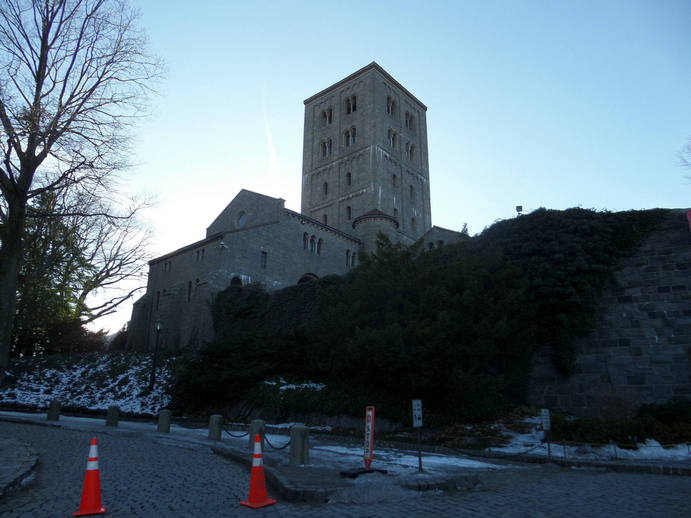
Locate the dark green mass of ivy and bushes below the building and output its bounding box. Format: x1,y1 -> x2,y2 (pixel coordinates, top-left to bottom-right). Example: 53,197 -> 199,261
174,209 -> 667,424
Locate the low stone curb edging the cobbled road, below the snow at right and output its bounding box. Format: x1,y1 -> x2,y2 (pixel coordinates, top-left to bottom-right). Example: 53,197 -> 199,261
456,449 -> 691,477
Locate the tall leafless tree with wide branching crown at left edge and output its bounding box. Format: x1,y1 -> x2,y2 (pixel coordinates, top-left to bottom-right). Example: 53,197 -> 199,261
0,0 -> 162,384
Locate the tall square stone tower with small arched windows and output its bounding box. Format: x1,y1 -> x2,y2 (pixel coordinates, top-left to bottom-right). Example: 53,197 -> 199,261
301,62 -> 432,251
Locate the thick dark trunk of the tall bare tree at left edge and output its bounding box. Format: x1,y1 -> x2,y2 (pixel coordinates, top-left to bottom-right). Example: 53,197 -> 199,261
0,202 -> 26,387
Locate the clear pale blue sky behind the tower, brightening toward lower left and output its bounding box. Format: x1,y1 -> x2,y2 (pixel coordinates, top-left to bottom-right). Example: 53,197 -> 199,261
96,0 -> 691,330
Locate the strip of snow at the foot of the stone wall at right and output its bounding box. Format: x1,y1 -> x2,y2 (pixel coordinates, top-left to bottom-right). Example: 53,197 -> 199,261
487,416 -> 691,462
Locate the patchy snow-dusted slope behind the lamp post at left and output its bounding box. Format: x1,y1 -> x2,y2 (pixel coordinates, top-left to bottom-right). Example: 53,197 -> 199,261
0,353 -> 170,414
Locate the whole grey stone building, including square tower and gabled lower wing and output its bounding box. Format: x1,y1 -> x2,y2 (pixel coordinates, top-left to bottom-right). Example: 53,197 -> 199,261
128,62 -> 464,349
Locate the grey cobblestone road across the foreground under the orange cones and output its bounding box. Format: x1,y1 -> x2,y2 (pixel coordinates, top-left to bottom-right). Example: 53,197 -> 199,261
0,422 -> 691,518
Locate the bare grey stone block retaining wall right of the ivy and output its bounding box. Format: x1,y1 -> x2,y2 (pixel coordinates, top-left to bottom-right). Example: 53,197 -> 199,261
530,210 -> 691,415
